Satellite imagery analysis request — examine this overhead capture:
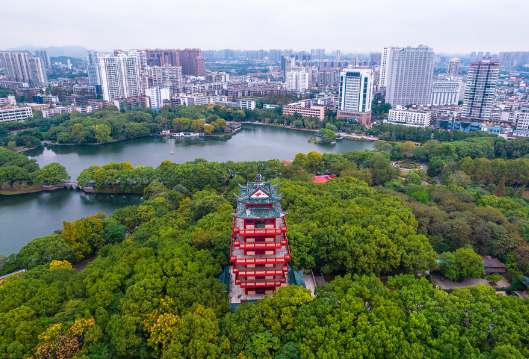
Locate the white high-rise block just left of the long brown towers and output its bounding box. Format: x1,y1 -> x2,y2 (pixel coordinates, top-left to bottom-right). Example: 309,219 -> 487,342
98,51 -> 143,102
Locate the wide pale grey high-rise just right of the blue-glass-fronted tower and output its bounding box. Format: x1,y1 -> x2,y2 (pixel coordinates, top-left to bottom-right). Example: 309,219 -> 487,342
381,45 -> 434,107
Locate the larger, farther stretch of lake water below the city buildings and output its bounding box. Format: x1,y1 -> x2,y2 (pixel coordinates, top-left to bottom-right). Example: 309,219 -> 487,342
25,124 -> 373,180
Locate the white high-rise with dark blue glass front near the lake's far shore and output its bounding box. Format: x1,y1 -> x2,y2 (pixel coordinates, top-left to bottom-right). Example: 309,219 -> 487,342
336,67 -> 373,125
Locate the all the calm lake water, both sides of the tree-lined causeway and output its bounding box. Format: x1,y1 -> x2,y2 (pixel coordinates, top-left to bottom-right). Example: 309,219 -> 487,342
0,124 -> 373,255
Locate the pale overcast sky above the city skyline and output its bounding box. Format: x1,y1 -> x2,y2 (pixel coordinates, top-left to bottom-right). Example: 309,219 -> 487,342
0,0 -> 529,53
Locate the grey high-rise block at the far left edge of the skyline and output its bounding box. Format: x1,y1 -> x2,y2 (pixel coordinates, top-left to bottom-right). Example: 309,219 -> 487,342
0,51 -> 48,86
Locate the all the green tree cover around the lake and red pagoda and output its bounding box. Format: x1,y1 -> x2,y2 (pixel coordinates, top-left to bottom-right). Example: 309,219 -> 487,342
0,105 -> 529,359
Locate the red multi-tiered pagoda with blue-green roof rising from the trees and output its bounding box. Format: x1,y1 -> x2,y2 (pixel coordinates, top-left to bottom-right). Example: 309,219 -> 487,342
230,174 -> 290,295
